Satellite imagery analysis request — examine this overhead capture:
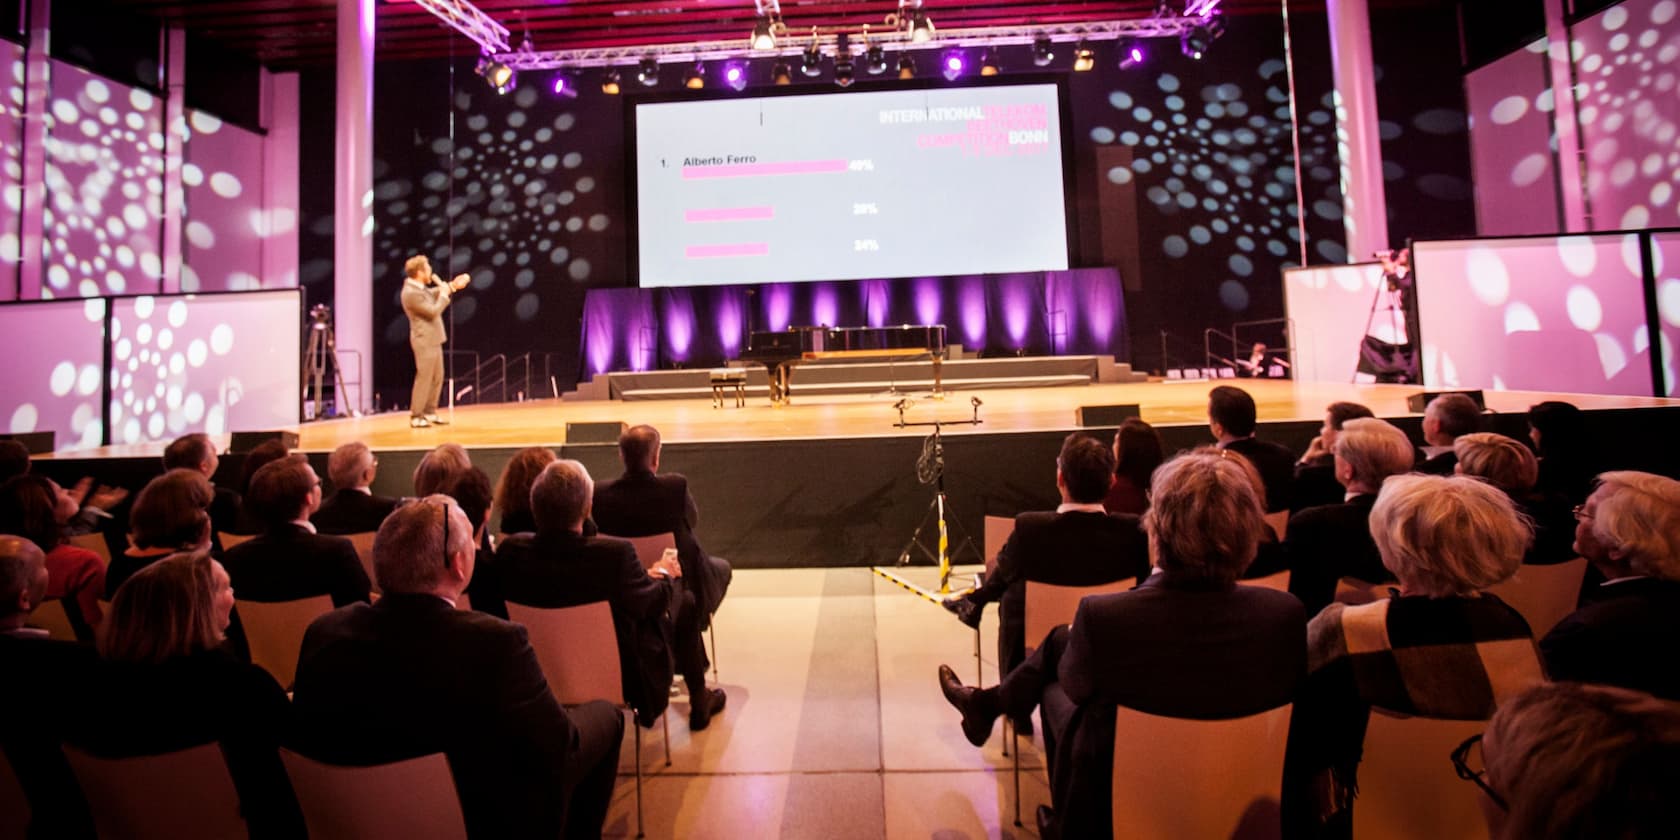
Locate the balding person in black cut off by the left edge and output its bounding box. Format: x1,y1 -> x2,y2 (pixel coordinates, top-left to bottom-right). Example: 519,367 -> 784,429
0,534 -> 102,838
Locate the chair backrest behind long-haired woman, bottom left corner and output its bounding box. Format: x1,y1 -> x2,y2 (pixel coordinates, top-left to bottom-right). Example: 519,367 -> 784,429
64,744 -> 247,840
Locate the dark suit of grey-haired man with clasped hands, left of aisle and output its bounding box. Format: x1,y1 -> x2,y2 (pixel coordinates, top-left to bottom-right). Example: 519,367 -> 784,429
496,531 -> 674,726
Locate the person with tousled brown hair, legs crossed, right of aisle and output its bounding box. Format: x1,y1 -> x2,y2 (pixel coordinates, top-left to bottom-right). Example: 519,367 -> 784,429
939,454 -> 1307,838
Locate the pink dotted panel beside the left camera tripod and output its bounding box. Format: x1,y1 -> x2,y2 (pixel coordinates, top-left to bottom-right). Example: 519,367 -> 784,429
111,289 -> 302,444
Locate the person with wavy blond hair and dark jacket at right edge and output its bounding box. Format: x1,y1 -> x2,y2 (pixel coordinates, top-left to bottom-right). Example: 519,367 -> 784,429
1541,472 -> 1680,701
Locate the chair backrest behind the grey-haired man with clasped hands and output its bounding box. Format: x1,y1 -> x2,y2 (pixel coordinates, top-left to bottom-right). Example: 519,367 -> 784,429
507,601 -> 625,706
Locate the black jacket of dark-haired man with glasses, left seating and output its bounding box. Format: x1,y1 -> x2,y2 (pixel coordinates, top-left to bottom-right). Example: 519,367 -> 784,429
222,522 -> 371,606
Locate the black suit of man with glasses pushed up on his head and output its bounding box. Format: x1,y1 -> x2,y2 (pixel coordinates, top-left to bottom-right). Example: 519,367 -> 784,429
292,593 -> 576,837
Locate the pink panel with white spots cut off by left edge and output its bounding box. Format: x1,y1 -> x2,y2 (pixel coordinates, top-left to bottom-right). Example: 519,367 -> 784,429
0,297 -> 106,450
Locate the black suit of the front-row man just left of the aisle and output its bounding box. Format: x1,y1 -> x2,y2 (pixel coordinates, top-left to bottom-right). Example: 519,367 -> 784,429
591,470 -> 727,628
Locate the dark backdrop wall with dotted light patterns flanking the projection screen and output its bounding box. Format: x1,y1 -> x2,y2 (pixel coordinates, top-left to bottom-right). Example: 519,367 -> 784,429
301,8 -> 1473,407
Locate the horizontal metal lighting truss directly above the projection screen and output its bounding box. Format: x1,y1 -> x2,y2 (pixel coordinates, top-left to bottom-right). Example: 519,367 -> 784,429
490,15 -> 1216,71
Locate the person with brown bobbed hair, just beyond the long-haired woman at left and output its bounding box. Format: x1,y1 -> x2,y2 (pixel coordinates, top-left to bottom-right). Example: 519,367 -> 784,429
106,469 -> 213,600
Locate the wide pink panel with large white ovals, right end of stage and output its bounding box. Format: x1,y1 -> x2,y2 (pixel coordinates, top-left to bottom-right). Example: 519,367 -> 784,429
1411,234 -> 1653,396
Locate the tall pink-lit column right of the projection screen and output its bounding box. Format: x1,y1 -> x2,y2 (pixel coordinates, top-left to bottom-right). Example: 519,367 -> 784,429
1324,0 -> 1388,262
